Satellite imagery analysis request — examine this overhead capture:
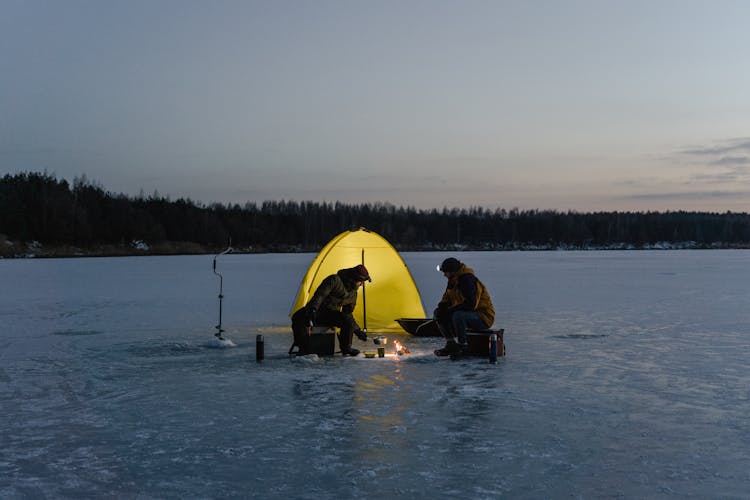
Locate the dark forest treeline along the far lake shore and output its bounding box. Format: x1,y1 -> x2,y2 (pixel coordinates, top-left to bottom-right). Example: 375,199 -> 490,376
0,172 -> 750,257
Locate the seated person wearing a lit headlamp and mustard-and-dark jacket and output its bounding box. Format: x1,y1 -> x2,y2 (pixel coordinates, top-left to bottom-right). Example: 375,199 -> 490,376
433,257 -> 495,356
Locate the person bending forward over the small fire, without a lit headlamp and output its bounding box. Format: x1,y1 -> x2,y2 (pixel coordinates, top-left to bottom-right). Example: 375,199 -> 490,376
292,264 -> 372,356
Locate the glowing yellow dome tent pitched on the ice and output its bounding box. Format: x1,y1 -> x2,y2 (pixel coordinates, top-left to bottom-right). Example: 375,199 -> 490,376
291,228 -> 424,333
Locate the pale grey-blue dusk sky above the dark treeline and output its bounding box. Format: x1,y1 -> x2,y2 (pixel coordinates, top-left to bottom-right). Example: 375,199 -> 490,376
0,0 -> 750,212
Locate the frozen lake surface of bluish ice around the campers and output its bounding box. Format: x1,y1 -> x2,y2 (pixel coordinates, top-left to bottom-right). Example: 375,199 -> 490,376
0,250 -> 750,499
